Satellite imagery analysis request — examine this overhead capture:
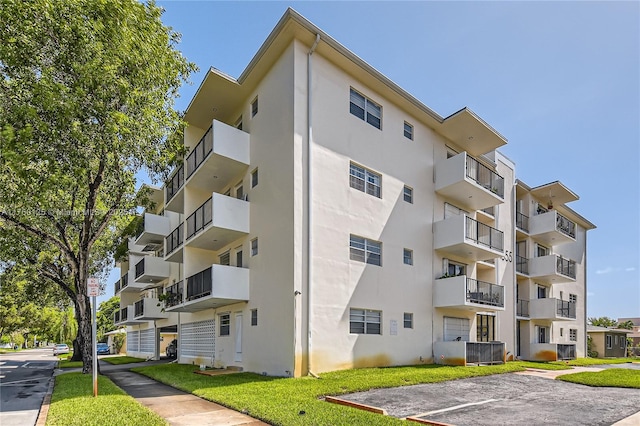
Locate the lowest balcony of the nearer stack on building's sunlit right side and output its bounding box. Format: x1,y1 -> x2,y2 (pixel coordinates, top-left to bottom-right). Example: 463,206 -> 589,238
433,275 -> 504,311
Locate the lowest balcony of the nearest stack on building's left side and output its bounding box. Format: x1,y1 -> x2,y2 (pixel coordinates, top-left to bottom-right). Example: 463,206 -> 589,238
166,264 -> 249,312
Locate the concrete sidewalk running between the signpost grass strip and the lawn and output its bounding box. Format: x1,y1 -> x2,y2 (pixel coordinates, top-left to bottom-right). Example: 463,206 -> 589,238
41,361 -> 268,426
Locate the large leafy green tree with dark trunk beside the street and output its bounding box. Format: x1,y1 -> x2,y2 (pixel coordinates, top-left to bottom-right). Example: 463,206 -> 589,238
0,0 -> 195,373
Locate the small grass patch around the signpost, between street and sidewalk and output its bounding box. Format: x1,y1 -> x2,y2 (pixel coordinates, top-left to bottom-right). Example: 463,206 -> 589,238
46,373 -> 167,426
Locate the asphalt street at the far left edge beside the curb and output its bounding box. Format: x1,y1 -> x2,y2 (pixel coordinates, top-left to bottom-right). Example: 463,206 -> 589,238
0,348 -> 57,426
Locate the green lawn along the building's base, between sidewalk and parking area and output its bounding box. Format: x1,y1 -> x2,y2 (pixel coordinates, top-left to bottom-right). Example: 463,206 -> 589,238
132,362 -> 525,426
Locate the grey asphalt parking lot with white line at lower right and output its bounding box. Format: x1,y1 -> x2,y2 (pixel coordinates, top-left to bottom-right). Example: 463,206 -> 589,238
341,366 -> 640,426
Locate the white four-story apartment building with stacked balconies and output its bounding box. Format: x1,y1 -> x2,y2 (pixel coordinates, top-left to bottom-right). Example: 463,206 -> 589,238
111,9 -> 595,376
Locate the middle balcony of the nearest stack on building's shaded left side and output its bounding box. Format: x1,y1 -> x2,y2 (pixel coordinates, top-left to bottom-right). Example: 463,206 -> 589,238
185,193 -> 249,250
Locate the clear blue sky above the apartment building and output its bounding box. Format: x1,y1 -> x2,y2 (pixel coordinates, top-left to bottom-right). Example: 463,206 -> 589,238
99,1 -> 640,318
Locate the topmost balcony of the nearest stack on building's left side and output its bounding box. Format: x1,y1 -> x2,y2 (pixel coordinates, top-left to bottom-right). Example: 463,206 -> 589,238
185,120 -> 250,192
